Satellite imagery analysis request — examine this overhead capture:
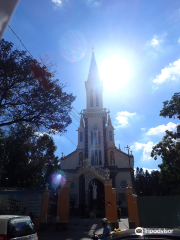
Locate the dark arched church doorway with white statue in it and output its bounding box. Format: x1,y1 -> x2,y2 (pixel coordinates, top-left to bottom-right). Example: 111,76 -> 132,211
88,178 -> 105,217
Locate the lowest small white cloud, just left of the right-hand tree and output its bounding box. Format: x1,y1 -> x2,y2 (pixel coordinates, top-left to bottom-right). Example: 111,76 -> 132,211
131,141 -> 155,160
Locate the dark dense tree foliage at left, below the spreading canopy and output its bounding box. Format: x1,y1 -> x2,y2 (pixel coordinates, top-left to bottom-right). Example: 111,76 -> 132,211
0,125 -> 60,189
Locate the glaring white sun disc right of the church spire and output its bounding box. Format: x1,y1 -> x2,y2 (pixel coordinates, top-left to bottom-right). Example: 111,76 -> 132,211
99,55 -> 130,91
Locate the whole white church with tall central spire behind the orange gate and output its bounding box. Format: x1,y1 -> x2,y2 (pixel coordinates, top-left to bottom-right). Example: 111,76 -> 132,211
61,52 -> 134,217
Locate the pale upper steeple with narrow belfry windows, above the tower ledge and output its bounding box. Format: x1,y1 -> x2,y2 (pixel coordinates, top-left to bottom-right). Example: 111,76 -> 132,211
85,51 -> 103,109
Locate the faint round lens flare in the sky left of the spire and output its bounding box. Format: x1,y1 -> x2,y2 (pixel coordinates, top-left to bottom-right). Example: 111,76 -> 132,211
60,30 -> 87,62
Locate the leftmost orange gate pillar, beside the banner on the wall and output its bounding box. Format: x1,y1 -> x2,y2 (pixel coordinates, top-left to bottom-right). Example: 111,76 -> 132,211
40,190 -> 50,230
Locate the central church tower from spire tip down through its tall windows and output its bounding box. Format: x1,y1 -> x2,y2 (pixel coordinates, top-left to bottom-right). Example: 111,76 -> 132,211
82,51 -> 107,167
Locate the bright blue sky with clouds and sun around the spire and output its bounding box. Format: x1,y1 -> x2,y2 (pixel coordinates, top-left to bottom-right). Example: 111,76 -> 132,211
4,0 -> 180,172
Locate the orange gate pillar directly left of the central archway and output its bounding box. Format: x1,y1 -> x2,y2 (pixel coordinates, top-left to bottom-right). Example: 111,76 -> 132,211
55,181 -> 70,230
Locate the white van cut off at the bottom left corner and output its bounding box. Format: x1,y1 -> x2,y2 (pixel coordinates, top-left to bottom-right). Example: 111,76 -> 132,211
0,215 -> 38,240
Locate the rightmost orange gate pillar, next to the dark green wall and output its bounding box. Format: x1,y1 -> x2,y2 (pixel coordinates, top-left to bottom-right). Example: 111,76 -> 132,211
126,187 -> 139,229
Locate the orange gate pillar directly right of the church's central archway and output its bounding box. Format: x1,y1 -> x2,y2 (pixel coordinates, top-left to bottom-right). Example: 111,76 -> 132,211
104,179 -> 119,230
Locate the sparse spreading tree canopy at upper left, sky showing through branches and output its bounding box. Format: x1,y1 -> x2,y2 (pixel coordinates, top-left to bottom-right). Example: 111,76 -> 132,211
0,40 -> 75,132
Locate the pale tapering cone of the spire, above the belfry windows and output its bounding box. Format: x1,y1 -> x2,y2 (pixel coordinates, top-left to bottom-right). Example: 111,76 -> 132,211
87,47 -> 100,81
